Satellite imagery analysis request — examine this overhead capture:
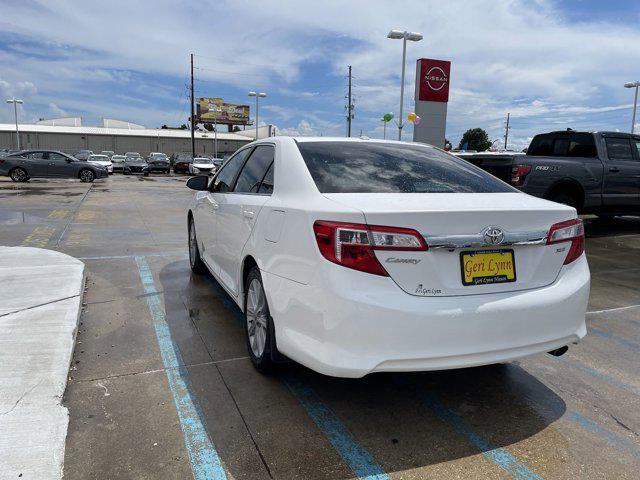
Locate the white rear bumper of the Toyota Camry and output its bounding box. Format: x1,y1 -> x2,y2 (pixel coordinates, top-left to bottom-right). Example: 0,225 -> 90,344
263,255 -> 590,377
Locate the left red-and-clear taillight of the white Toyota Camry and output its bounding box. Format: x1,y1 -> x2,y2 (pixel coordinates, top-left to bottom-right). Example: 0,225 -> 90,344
313,220 -> 427,277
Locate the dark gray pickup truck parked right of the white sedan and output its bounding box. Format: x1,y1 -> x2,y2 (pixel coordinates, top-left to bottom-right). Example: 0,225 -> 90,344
458,130 -> 640,217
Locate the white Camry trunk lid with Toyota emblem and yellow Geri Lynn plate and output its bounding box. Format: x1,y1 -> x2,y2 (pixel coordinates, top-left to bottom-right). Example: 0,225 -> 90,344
325,192 -> 576,296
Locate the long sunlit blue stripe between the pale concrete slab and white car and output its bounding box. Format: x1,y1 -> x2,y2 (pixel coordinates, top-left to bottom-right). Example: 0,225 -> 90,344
135,256 -> 227,480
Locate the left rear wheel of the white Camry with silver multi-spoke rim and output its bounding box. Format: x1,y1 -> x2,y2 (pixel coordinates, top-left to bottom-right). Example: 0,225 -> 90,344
244,266 -> 277,373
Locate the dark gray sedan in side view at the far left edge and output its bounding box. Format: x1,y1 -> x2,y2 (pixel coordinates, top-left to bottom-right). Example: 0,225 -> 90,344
0,150 -> 109,182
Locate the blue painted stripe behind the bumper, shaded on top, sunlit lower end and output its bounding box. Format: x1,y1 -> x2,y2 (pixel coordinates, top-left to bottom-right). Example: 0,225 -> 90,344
414,385 -> 542,480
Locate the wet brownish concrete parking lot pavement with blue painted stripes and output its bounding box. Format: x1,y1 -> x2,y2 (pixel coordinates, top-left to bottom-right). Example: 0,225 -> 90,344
0,175 -> 640,479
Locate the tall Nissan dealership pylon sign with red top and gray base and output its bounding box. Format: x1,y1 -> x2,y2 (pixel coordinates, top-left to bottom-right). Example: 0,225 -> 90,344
413,58 -> 451,148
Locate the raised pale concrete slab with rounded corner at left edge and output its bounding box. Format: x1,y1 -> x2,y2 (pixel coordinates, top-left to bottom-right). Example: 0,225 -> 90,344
0,247 -> 85,479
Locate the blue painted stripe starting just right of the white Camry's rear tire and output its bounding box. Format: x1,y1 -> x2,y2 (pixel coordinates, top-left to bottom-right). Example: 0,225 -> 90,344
282,375 -> 389,480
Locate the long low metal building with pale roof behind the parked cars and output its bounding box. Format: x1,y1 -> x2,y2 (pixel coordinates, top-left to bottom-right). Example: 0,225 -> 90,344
0,124 -> 252,157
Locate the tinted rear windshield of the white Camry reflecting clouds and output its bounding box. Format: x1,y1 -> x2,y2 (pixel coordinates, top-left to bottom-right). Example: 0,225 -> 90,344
298,142 -> 516,193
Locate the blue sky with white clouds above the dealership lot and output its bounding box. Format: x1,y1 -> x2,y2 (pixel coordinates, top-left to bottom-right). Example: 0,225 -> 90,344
0,0 -> 640,148
